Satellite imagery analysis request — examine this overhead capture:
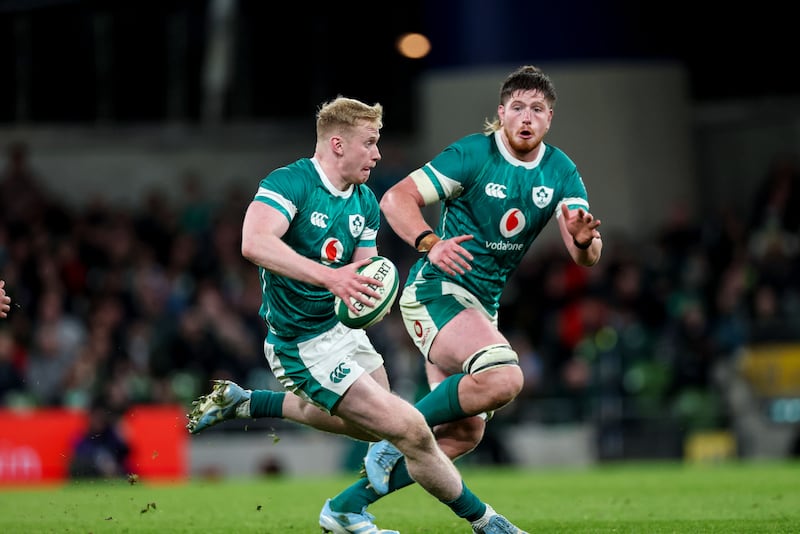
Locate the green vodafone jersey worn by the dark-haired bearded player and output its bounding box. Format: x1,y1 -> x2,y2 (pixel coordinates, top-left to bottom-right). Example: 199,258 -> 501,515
406,132 -> 589,313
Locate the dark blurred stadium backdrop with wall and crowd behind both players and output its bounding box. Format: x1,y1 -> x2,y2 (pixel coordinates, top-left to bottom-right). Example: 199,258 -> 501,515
0,0 -> 800,484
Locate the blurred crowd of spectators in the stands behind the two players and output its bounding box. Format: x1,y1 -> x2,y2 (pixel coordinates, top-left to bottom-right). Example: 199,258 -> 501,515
0,142 -> 800,446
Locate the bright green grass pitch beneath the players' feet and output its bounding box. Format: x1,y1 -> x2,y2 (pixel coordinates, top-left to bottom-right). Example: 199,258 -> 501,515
0,462 -> 800,534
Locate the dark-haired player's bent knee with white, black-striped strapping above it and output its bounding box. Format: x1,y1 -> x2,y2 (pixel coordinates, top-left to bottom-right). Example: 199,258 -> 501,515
462,344 -> 524,408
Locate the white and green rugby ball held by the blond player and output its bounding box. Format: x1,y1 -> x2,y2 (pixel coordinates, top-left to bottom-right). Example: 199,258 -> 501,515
334,256 -> 400,328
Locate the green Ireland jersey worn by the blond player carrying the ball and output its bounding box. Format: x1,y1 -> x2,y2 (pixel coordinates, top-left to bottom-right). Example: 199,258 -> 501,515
254,158 -> 380,341
